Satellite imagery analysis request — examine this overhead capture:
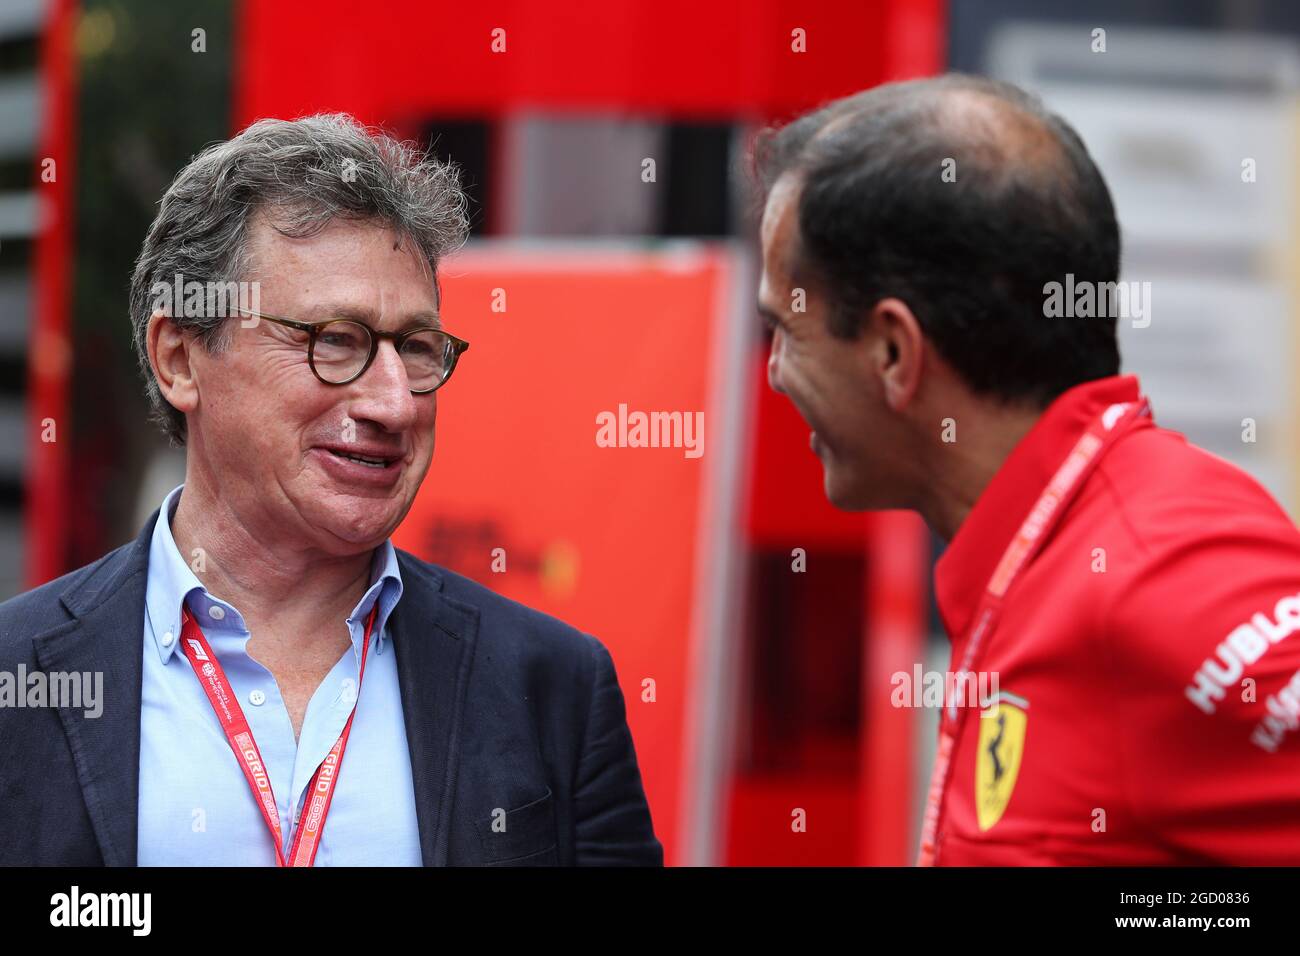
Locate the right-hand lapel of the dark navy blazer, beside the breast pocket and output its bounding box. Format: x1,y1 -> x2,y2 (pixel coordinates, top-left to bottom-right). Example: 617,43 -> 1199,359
389,549 -> 478,866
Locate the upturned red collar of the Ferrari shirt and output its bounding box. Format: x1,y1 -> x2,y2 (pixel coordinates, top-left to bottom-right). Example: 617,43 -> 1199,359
935,375 -> 1140,641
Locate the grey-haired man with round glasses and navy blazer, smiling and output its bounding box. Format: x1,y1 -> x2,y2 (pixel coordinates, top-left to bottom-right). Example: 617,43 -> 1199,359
0,116 -> 663,866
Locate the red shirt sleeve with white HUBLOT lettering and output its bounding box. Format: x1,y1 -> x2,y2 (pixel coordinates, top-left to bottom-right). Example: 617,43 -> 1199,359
1097,511 -> 1300,865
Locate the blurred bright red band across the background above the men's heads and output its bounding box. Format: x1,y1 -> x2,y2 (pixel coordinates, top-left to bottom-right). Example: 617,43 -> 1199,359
234,0 -> 944,125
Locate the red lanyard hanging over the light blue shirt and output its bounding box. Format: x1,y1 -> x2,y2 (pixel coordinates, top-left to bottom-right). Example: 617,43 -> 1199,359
181,601 -> 380,866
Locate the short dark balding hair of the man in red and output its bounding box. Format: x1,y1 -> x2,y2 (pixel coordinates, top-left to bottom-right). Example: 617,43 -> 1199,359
754,74 -> 1119,406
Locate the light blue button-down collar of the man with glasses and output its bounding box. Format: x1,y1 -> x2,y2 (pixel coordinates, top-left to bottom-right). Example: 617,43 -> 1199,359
144,484 -> 403,663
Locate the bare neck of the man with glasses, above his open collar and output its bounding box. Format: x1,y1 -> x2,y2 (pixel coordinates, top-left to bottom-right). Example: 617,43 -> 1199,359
171,468 -> 373,646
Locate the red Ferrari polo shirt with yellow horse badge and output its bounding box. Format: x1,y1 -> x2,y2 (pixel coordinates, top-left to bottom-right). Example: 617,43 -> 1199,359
933,376 -> 1300,865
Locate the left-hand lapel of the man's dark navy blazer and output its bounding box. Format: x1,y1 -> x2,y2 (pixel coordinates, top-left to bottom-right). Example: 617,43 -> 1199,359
33,511 -> 159,866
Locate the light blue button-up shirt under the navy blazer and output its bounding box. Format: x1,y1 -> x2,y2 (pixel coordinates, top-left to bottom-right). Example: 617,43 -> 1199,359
138,485 -> 421,866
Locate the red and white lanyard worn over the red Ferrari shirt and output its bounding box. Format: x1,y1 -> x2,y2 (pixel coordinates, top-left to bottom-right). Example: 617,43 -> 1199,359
917,399 -> 1151,866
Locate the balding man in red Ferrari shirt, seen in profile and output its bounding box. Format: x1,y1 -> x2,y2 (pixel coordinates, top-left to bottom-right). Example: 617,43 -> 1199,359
757,75 -> 1300,865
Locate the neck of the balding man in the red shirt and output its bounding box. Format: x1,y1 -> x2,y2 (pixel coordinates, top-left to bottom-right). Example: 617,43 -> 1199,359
917,406 -> 1043,541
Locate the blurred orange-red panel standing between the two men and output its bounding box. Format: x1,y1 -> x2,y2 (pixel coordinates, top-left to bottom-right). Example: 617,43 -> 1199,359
395,247 -> 727,862
